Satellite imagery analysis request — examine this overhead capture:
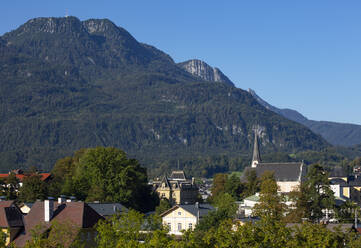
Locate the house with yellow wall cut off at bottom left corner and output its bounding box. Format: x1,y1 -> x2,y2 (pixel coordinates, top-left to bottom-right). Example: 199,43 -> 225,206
0,201 -> 24,245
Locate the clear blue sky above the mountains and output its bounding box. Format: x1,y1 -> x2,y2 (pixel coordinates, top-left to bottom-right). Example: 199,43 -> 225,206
0,0 -> 361,124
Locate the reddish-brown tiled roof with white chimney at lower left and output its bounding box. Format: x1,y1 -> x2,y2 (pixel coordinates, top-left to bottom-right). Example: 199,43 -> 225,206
14,201 -> 104,247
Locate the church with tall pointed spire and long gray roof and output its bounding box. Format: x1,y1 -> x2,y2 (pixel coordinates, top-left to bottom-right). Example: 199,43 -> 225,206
245,133 -> 306,193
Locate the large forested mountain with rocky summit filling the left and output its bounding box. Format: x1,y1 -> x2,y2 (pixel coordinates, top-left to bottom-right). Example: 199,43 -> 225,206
0,17 -> 328,176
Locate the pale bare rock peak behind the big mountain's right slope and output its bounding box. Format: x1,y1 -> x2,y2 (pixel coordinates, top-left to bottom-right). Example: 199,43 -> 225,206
178,59 -> 234,86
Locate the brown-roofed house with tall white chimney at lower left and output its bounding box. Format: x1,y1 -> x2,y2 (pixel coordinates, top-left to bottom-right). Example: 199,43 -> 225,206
13,198 -> 104,247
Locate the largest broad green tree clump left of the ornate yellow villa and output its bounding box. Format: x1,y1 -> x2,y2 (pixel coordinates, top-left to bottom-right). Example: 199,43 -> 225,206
54,147 -> 157,211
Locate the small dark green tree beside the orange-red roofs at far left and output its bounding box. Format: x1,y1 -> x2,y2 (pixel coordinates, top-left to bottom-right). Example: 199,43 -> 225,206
19,174 -> 47,202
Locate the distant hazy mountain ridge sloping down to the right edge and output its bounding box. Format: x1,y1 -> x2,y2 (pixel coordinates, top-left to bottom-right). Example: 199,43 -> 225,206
248,89 -> 361,147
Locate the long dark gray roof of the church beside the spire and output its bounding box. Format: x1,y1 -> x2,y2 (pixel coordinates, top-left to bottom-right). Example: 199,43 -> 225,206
244,162 -> 306,182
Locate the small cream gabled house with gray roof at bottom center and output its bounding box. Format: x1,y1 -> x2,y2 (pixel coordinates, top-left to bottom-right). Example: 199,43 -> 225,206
160,202 -> 214,235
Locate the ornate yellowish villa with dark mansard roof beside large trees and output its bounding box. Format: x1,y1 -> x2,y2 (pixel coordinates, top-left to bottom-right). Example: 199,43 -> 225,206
152,171 -> 198,205
